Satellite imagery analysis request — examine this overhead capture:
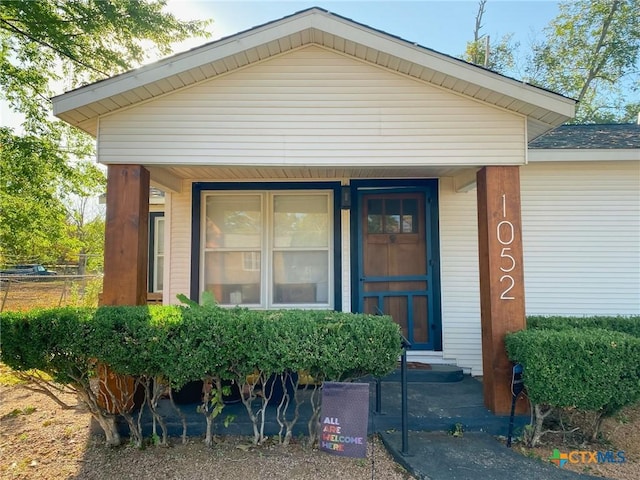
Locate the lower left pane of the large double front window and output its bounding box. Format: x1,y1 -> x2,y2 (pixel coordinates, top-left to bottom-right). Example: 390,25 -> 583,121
204,252 -> 261,305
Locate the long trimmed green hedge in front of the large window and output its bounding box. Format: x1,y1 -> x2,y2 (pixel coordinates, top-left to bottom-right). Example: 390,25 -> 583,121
0,306 -> 401,387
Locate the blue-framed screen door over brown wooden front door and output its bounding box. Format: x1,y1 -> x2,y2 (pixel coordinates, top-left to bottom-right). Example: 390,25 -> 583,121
356,188 -> 442,350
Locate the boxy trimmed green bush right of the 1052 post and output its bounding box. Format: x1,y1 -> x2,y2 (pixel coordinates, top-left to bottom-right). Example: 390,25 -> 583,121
505,328 -> 640,416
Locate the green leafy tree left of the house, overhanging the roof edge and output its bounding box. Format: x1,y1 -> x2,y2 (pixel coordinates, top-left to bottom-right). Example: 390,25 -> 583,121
0,0 -> 209,262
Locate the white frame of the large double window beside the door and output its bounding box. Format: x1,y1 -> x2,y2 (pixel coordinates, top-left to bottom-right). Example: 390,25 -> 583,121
199,189 -> 335,310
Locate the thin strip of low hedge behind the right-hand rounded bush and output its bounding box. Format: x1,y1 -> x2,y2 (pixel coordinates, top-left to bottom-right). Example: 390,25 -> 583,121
527,315 -> 640,338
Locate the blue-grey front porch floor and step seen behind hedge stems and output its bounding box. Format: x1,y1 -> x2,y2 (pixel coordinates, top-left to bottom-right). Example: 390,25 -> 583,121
114,365 -> 529,448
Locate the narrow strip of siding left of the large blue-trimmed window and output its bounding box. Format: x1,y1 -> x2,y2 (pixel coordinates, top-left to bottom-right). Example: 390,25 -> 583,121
163,181 -> 191,304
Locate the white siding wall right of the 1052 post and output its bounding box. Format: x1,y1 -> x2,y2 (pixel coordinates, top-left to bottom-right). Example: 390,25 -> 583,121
521,162 -> 640,315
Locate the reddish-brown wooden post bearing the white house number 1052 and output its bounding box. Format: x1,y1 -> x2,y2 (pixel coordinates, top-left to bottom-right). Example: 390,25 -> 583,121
477,166 -> 527,414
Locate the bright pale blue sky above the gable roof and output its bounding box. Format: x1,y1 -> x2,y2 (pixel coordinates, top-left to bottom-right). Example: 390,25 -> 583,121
0,0 -> 558,127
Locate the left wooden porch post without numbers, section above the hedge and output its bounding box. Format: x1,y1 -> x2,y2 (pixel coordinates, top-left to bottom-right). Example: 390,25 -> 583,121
102,165 -> 149,305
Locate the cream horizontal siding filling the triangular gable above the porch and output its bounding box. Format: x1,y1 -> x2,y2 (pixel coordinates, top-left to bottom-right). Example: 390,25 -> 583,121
98,46 -> 525,166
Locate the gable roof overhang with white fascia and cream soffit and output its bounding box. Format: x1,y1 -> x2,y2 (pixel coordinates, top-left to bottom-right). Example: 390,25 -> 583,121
52,7 -> 575,140
